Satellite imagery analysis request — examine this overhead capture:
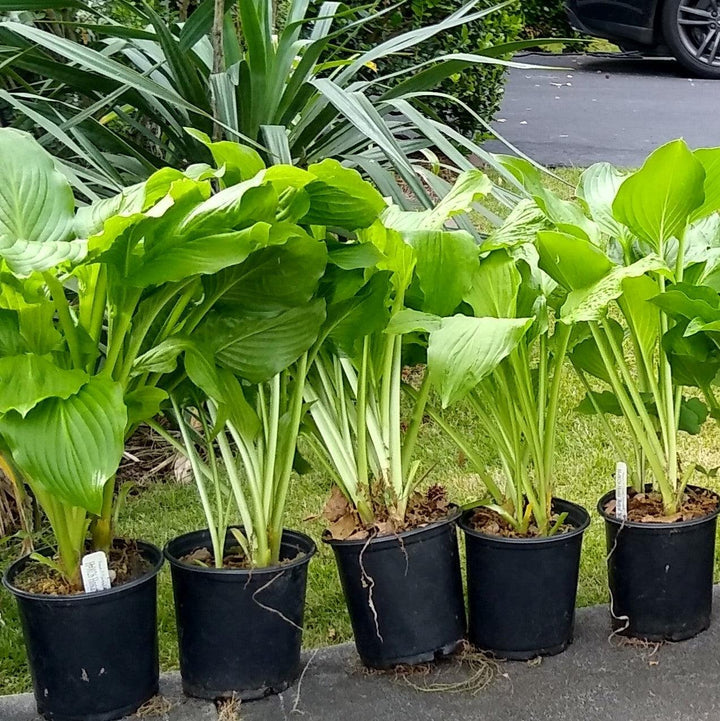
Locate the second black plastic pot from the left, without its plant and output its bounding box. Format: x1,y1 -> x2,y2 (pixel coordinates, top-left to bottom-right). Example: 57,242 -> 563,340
165,530 -> 316,701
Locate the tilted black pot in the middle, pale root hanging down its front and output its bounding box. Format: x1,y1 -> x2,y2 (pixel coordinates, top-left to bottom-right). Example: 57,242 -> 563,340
326,511 -> 465,668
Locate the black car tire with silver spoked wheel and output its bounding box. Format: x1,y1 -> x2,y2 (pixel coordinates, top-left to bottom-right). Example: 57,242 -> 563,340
662,0 -> 720,79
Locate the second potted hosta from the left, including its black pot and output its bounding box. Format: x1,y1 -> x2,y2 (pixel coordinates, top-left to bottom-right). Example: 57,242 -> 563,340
147,155 -> 400,699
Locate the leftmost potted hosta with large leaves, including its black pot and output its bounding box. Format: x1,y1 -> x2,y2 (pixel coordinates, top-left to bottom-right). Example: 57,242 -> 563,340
0,130 -> 344,720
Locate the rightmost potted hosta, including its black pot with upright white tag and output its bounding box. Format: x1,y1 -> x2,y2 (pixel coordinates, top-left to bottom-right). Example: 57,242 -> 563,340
516,141 -> 720,640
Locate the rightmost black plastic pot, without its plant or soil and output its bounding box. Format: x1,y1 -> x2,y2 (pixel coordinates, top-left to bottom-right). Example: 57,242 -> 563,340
598,489 -> 720,641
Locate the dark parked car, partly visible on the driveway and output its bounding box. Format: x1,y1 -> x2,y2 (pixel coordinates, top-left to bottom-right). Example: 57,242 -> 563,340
567,0 -> 720,78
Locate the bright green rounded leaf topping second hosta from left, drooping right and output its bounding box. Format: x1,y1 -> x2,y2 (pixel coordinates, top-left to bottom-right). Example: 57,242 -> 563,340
303,159 -> 385,231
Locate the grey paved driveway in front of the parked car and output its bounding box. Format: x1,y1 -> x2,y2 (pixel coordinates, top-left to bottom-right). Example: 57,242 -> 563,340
485,55 -> 720,167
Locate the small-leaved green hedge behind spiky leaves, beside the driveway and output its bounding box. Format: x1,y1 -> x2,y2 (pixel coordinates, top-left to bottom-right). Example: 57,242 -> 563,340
356,0 -> 523,136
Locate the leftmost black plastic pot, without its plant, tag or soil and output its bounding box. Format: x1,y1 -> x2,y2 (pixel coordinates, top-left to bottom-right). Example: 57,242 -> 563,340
3,542 -> 163,721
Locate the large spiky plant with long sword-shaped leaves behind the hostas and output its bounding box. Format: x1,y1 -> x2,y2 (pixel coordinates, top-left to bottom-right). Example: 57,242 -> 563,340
0,0 -> 544,206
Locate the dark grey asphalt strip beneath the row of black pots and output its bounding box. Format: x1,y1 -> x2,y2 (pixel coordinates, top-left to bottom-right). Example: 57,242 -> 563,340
7,589 -> 720,721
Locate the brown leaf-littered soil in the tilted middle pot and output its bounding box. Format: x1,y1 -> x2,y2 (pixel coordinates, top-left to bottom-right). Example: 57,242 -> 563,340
323,486 -> 455,541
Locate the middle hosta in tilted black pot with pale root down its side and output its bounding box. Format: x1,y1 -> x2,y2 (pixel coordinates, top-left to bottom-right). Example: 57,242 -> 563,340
305,171 -> 489,668
